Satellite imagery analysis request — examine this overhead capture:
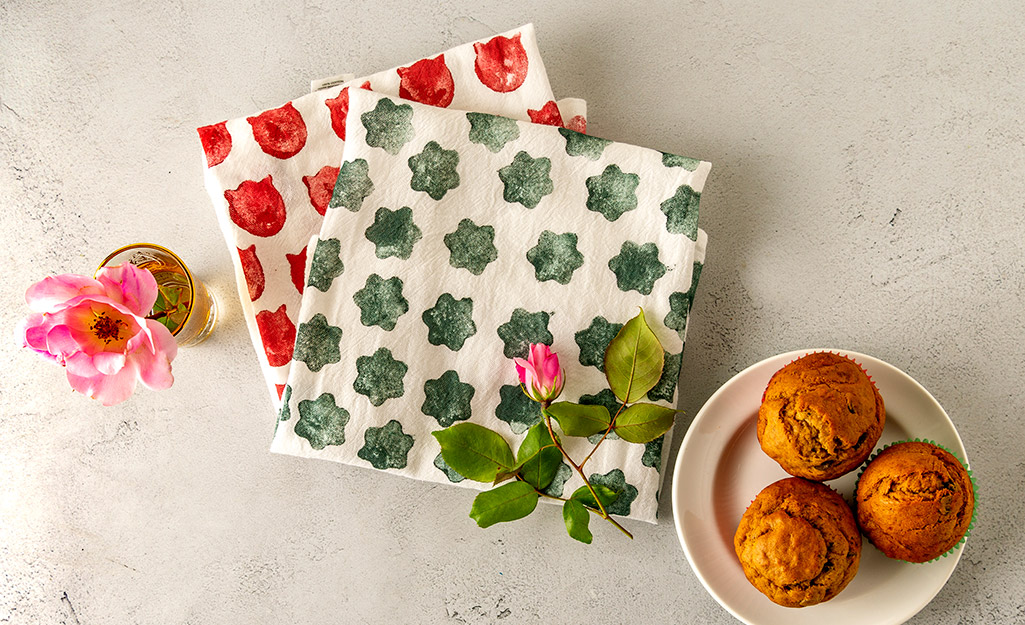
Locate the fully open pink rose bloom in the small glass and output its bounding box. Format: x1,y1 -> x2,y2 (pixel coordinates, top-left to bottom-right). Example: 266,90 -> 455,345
15,263 -> 178,406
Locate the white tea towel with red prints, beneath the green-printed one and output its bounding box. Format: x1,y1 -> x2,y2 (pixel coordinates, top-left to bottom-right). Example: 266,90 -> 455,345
199,24 -> 586,410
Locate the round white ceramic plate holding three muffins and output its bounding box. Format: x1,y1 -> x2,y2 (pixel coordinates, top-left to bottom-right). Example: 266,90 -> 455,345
672,349 -> 968,625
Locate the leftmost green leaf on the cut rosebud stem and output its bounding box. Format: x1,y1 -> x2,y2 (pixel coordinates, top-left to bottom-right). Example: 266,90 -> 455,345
431,423 -> 516,482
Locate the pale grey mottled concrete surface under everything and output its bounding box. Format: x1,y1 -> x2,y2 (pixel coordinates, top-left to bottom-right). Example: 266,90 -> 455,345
0,0 -> 1025,625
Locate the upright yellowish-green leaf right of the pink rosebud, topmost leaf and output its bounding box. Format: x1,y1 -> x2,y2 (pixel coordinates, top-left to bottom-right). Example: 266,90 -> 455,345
605,308 -> 665,404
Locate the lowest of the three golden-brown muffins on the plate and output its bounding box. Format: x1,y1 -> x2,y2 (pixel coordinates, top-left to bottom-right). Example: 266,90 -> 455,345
733,477 -> 861,608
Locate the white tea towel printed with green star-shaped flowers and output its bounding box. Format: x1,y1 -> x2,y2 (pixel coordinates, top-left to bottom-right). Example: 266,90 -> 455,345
272,91 -> 710,522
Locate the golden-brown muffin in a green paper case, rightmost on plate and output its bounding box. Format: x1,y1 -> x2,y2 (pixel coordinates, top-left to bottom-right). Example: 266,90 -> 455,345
857,442 -> 975,563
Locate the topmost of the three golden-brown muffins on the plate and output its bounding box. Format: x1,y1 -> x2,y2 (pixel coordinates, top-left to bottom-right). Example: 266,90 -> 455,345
757,351 -> 887,482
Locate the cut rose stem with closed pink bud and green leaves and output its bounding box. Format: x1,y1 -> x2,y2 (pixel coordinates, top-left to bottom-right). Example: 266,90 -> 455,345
434,310 -> 677,544
